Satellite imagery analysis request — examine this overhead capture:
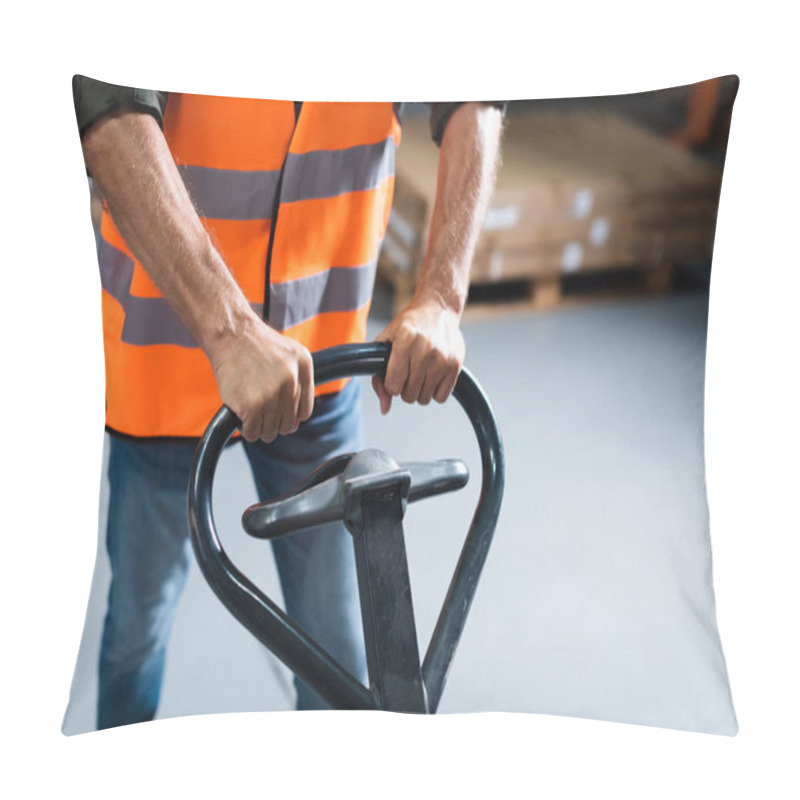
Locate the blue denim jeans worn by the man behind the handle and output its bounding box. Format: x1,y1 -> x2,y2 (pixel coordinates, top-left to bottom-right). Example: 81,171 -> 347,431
97,380 -> 366,729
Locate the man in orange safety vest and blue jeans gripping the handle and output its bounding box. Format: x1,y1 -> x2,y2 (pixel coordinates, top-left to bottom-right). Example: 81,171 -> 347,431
73,76 -> 503,728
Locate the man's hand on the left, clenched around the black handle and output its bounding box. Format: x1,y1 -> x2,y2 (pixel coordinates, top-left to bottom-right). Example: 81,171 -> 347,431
208,316 -> 314,442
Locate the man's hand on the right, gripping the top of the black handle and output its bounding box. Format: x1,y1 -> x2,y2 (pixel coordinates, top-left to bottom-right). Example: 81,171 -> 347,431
372,298 -> 465,414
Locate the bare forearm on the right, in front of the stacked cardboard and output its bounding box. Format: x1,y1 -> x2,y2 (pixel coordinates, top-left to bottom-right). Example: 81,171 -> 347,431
415,103 -> 503,315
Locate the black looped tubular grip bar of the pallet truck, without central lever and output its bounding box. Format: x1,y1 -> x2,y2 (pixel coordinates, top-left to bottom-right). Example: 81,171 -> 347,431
188,342 -> 505,713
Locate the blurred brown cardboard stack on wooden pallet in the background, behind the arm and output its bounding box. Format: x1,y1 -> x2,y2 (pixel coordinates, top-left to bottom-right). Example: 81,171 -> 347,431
381,110 -> 721,306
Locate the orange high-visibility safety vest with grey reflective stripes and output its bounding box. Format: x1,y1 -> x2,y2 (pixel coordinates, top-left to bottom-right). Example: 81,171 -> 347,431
99,94 -> 400,444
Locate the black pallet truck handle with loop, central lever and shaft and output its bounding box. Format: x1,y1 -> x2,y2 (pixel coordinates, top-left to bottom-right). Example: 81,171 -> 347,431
189,342 -> 505,714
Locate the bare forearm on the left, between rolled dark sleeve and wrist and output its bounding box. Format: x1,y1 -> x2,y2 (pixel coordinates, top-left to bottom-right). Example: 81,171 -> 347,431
83,112 -> 255,362
